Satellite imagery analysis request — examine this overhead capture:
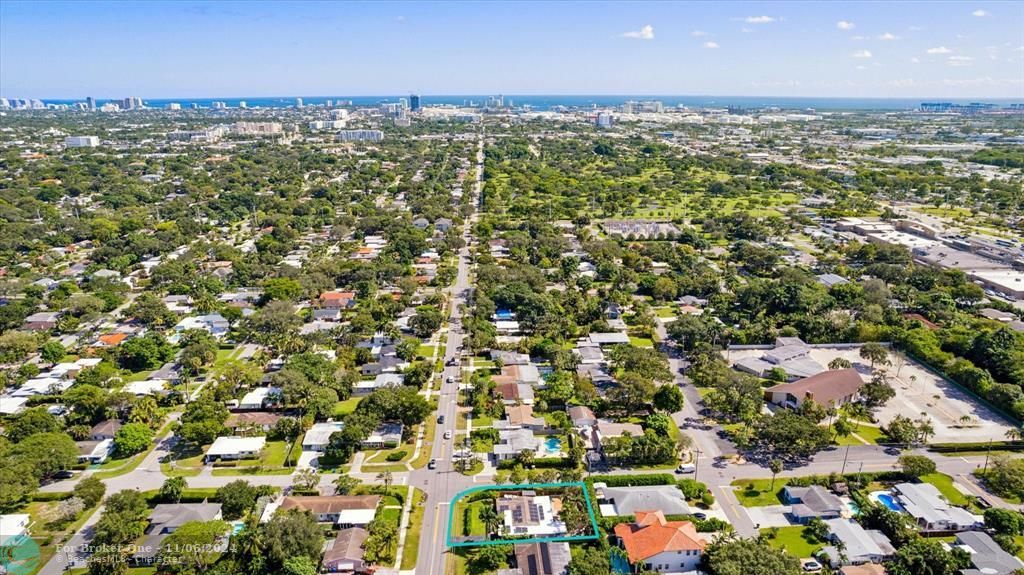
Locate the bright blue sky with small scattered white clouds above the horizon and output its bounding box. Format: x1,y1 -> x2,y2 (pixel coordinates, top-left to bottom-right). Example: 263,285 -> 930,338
0,0 -> 1024,98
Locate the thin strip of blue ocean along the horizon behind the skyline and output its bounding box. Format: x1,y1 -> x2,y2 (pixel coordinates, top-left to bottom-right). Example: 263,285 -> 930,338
37,94 -> 1024,110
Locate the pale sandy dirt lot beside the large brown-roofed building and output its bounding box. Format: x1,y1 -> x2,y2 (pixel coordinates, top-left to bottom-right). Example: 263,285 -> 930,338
729,341 -> 1011,443
